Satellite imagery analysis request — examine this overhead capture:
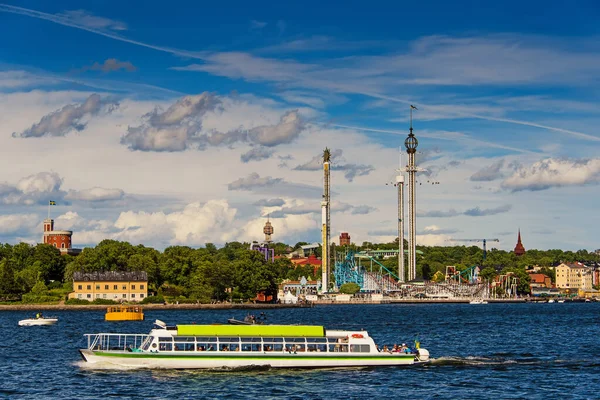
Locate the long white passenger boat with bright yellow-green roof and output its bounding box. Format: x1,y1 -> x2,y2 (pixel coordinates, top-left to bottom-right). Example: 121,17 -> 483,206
79,320 -> 429,369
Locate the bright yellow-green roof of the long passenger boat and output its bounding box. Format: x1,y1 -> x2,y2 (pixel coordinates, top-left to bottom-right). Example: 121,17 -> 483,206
177,325 -> 325,337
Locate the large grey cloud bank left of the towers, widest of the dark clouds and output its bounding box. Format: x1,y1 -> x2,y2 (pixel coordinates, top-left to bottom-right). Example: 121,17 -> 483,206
121,92 -> 304,152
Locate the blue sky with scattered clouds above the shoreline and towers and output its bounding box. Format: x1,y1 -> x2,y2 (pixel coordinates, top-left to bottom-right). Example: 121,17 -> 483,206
0,1 -> 600,250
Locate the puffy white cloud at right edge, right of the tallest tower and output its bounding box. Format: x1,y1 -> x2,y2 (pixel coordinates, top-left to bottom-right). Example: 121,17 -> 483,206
502,158 -> 600,192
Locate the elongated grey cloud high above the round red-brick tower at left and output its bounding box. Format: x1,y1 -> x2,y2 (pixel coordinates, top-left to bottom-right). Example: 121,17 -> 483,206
12,94 -> 119,138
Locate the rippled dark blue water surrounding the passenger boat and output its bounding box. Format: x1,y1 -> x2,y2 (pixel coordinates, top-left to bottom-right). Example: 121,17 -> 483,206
0,303 -> 600,399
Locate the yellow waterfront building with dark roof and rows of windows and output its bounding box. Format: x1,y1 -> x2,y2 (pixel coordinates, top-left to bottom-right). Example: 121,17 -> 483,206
69,271 -> 148,301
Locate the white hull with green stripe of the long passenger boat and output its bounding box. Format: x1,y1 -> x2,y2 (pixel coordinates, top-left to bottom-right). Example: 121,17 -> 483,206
79,349 -> 415,369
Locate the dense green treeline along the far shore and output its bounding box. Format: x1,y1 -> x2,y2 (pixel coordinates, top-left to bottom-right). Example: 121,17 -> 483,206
0,240 -> 600,302
